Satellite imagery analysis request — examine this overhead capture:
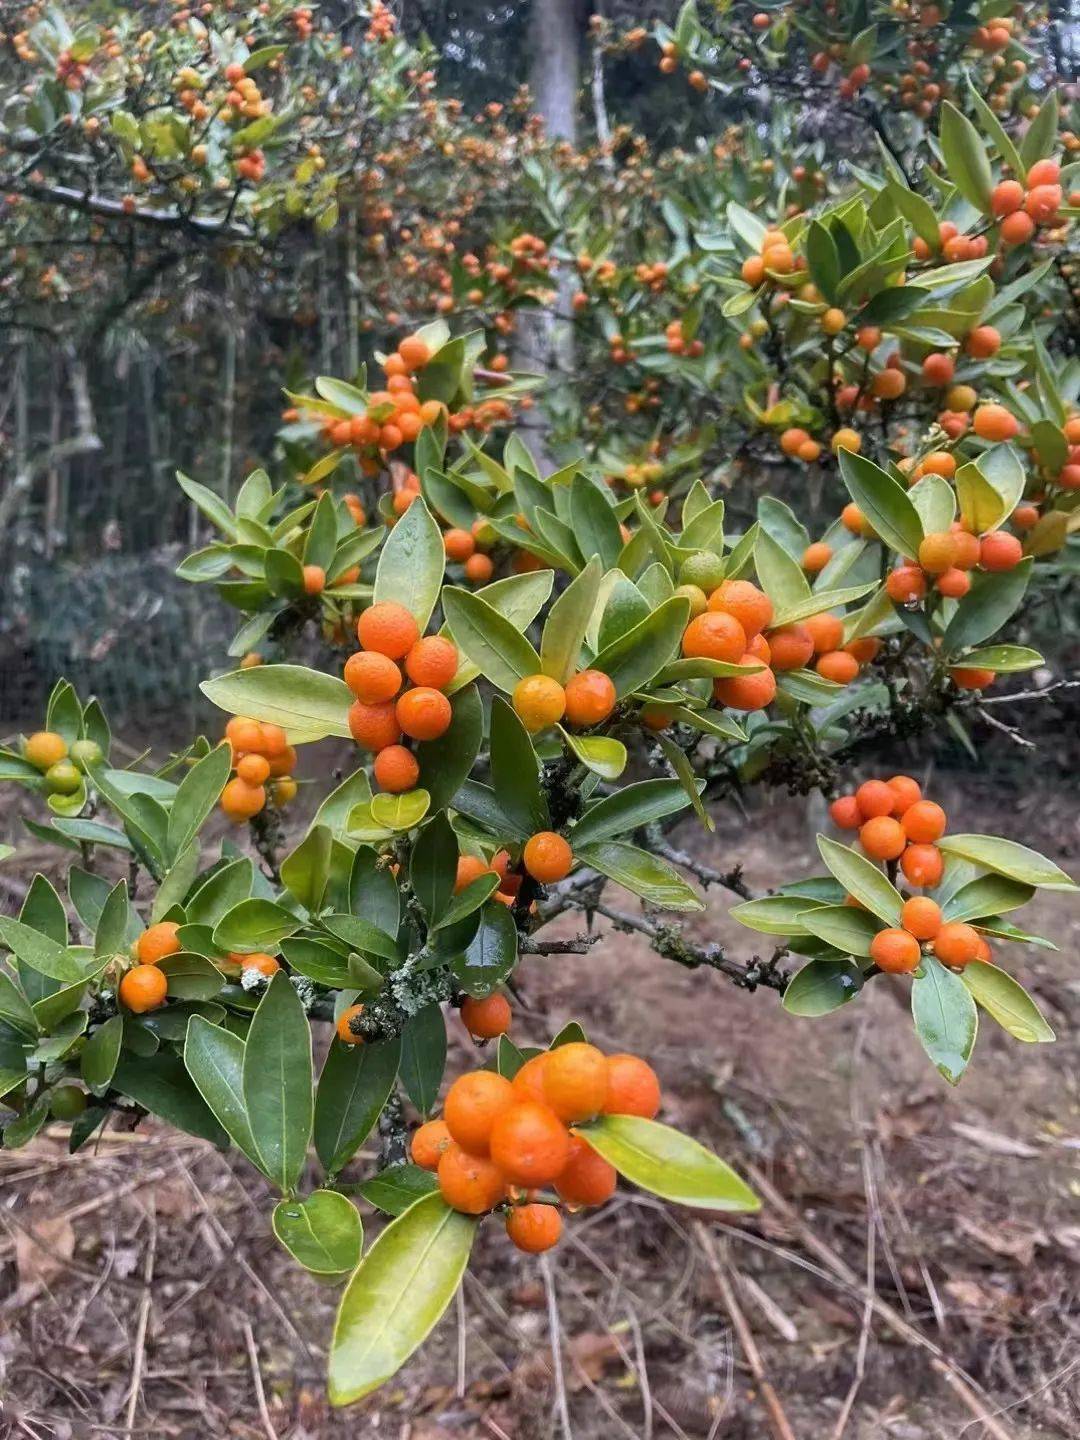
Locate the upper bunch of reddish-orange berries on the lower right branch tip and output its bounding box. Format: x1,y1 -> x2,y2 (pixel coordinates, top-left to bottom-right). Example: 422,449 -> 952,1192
829,775 -> 946,890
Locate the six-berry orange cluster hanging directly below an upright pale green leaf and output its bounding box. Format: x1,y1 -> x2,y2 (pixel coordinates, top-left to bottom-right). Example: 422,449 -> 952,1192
344,600 -> 458,795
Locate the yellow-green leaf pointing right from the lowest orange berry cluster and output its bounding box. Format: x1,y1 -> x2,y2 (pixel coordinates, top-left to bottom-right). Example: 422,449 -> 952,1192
573,1115 -> 762,1214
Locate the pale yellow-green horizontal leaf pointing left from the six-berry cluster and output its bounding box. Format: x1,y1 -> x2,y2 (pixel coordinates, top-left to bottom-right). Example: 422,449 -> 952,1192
199,662 -> 352,744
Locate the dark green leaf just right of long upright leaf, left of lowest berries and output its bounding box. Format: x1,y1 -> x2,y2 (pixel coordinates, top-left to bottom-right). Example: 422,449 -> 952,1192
315,1038 -> 402,1175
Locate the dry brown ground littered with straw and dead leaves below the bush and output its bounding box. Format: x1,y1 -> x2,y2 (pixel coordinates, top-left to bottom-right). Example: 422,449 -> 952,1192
0,776 -> 1080,1440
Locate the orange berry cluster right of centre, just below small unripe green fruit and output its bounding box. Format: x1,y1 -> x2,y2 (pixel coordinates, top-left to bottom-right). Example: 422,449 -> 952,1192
683,580 -> 881,710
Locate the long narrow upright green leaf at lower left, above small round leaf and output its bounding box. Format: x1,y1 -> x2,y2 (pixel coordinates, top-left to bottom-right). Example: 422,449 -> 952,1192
242,971 -> 312,1191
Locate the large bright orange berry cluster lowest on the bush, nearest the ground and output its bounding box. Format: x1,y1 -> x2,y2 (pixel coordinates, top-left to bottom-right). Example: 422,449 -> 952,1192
412,1041 -> 660,1254
